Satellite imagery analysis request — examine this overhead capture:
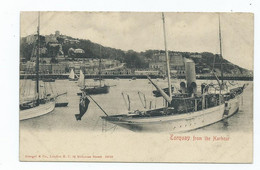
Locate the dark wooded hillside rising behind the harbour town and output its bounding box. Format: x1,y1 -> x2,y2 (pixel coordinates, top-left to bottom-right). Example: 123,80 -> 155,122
20,36 -> 252,74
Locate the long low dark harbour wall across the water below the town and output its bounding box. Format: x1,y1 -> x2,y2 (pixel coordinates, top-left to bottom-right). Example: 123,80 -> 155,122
20,74 -> 253,81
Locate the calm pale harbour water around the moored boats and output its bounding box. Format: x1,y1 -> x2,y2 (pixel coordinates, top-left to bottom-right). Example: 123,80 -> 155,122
20,79 -> 253,132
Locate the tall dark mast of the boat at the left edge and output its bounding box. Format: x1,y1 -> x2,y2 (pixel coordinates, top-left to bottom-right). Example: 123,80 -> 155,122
35,12 -> 40,105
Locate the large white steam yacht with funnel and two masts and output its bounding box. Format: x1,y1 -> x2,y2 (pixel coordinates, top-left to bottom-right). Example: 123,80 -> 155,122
101,14 -> 245,132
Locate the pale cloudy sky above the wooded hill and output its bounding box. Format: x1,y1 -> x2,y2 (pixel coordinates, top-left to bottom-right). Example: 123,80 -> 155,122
20,12 -> 254,70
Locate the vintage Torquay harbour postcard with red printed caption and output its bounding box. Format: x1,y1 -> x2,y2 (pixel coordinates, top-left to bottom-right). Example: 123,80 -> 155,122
19,11 -> 254,163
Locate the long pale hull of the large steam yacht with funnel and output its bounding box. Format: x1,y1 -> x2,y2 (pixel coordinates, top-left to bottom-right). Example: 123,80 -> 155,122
102,96 -> 240,132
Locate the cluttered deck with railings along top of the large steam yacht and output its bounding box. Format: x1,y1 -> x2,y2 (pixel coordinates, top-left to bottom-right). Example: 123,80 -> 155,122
102,87 -> 243,121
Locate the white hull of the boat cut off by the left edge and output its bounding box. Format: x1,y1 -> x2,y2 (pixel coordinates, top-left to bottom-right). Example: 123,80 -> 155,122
19,101 -> 55,120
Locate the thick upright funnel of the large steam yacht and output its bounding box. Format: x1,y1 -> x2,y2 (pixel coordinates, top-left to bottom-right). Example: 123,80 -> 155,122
185,59 -> 197,93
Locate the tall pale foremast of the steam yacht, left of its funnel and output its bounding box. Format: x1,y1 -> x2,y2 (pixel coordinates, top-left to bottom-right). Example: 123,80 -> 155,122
162,13 -> 172,99
